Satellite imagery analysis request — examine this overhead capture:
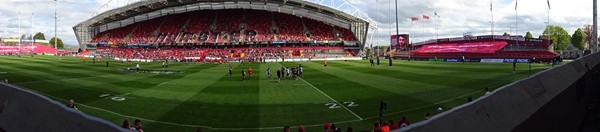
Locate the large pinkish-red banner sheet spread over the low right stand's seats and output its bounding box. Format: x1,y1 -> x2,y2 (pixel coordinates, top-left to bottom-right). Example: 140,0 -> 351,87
414,41 -> 507,53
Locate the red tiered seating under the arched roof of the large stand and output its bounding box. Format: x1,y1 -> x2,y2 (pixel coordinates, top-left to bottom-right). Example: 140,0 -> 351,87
91,9 -> 356,45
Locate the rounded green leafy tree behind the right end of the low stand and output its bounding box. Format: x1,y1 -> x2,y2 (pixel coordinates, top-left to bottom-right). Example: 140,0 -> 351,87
544,25 -> 571,50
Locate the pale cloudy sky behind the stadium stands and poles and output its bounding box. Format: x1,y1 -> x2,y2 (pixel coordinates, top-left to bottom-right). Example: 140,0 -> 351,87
0,0 -> 592,45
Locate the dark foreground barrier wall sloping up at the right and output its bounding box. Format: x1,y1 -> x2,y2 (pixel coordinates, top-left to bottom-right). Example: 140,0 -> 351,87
398,53 -> 600,132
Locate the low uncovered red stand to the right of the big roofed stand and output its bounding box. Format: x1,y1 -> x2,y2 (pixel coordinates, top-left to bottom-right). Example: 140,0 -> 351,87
395,36 -> 558,62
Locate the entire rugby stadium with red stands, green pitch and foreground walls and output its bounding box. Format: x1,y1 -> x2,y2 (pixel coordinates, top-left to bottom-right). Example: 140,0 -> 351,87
0,0 -> 600,132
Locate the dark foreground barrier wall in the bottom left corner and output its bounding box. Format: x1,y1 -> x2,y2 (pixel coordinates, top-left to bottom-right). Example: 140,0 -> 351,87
0,83 -> 125,132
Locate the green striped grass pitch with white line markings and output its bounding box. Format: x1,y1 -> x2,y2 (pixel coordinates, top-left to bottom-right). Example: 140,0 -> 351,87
0,56 -> 549,132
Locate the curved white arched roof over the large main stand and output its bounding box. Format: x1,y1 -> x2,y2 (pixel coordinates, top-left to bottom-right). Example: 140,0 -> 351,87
73,0 -> 377,47
